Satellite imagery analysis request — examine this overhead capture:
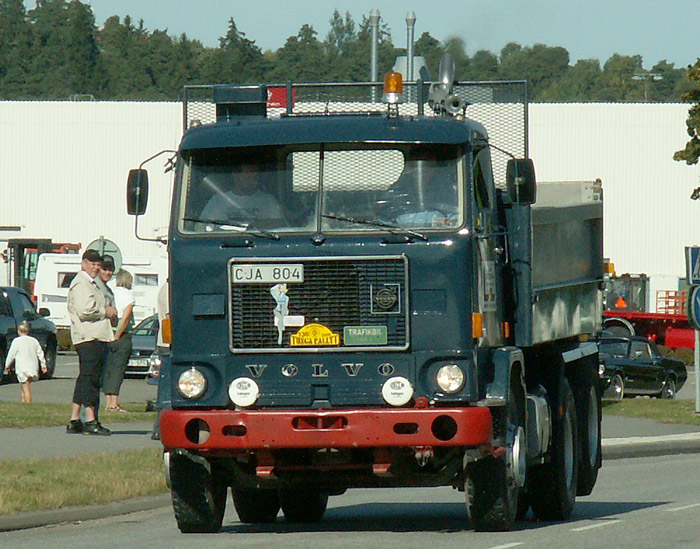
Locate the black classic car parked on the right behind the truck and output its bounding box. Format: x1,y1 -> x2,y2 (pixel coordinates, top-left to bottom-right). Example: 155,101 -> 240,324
598,336 -> 688,399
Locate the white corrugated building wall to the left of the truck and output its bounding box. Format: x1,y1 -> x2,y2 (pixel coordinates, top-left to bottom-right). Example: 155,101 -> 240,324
0,102 -> 182,283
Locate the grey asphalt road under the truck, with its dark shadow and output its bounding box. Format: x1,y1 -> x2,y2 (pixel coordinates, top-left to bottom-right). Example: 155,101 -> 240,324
0,455 -> 700,549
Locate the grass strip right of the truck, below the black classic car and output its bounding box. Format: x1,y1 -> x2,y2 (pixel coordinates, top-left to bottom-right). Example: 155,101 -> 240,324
603,398 -> 700,425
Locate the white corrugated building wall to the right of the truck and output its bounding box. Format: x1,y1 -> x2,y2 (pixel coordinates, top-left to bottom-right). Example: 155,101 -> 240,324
530,103 -> 700,296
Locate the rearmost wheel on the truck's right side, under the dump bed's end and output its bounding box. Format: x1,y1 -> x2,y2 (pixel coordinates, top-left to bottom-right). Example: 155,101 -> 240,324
574,367 -> 602,496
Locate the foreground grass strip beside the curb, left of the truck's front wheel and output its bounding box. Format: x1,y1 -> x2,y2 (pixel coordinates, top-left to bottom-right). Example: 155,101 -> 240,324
0,448 -> 167,515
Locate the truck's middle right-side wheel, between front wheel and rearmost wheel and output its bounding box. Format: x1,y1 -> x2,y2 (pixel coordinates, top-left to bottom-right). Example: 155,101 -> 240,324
528,379 -> 578,520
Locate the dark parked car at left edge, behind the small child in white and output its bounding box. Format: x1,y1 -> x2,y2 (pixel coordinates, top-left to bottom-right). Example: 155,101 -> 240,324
0,286 -> 57,380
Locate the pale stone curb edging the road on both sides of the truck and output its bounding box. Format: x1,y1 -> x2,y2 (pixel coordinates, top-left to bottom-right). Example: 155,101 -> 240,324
0,433 -> 700,532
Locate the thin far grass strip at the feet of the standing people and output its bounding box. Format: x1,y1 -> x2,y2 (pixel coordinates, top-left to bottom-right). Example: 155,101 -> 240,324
0,402 -> 156,429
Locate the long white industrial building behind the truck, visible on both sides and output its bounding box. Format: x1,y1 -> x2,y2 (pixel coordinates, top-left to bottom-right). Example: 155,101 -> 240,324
0,98 -> 700,304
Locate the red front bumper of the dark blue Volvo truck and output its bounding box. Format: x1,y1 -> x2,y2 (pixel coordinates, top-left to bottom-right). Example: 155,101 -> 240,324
160,407 -> 492,454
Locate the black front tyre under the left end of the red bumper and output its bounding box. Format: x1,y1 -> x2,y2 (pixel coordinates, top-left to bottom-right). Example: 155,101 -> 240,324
170,454 -> 227,534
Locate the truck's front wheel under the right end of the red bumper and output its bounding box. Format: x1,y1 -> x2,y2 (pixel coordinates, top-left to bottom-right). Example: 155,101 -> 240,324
464,376 -> 527,532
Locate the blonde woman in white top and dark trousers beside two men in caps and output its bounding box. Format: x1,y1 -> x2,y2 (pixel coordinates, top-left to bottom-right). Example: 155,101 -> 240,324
102,269 -> 134,412
